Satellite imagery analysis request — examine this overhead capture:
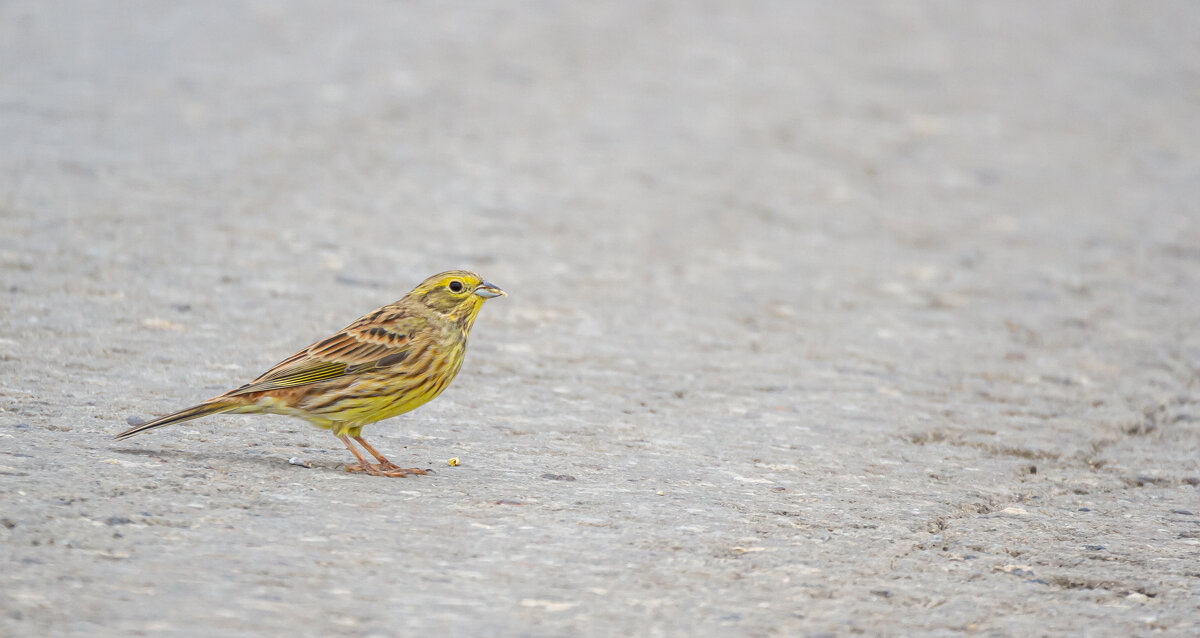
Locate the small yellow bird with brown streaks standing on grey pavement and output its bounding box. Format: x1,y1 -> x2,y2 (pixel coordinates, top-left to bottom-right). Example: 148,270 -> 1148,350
116,270 -> 508,476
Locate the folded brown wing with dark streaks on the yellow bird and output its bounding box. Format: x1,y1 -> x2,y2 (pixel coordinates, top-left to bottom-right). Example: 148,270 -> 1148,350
227,309 -> 428,396
